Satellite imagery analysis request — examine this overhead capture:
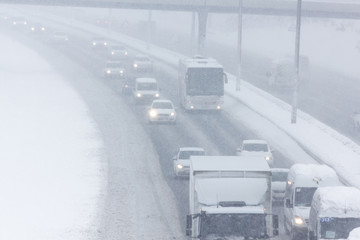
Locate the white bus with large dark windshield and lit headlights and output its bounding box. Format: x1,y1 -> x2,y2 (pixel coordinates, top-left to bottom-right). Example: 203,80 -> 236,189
179,56 -> 227,110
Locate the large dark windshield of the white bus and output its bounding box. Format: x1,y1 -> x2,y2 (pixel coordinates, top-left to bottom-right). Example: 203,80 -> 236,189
186,68 -> 224,96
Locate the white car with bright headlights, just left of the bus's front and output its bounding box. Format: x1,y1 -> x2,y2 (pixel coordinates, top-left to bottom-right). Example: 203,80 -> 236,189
148,99 -> 176,124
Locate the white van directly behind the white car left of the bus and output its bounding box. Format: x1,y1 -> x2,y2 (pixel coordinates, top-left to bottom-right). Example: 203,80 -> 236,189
133,77 -> 160,104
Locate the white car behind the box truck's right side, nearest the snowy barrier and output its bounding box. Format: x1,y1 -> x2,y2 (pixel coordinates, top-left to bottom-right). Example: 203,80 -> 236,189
236,140 -> 274,167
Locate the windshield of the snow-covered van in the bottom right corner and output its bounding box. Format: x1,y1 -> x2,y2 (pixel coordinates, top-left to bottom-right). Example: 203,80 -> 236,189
320,217 -> 360,239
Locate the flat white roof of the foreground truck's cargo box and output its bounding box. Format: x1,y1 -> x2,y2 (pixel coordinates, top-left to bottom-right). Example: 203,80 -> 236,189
190,156 -> 271,172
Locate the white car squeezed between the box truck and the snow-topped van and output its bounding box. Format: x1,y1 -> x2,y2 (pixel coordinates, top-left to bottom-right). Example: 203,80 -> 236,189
271,168 -> 289,202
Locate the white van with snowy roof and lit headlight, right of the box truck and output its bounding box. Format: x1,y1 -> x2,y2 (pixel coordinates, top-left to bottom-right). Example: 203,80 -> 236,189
284,164 -> 342,239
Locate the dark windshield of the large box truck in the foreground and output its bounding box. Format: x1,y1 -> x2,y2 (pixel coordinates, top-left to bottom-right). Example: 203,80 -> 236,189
200,214 -> 266,238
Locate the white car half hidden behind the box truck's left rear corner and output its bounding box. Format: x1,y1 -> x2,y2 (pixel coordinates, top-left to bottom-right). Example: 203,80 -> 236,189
172,147 -> 205,176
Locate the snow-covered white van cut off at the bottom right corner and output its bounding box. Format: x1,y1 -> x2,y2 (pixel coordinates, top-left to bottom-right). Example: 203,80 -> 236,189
308,186 -> 360,240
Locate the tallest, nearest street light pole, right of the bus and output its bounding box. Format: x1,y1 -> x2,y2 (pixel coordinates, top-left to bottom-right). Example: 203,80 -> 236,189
291,0 -> 302,124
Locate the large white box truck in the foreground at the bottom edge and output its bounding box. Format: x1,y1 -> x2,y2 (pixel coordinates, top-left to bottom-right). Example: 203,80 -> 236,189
186,156 -> 278,240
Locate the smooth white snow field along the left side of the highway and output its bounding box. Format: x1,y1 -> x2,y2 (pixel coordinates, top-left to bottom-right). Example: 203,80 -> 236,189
0,35 -> 106,240
